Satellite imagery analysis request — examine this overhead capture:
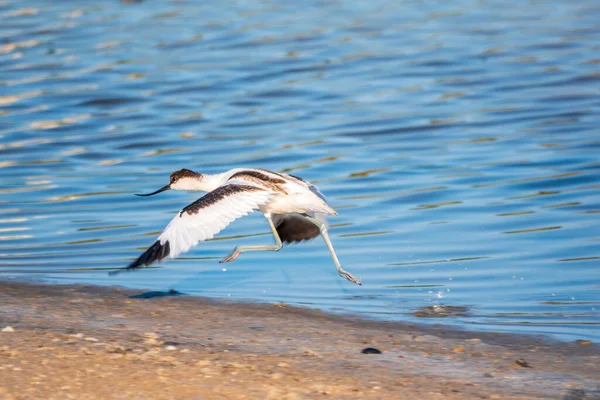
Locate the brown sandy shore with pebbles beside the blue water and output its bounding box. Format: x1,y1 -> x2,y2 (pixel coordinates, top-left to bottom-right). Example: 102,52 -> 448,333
0,282 -> 600,400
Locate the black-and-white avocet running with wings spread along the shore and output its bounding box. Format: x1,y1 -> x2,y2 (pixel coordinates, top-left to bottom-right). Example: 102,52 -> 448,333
110,168 -> 362,285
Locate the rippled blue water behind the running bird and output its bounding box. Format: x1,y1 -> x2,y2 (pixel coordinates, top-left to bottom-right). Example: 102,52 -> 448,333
0,0 -> 600,340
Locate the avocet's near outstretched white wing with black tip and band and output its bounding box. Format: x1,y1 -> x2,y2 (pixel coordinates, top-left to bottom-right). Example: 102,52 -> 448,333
113,184 -> 272,274
